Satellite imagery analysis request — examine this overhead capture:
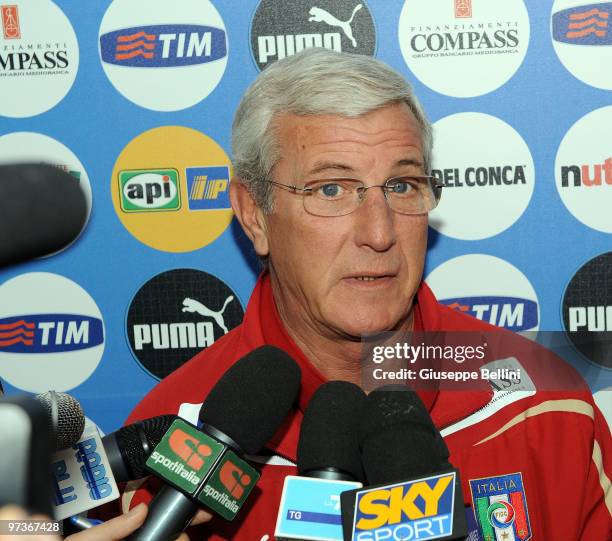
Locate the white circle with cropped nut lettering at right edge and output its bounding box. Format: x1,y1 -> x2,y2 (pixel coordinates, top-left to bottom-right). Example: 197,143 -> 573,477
555,106 -> 612,233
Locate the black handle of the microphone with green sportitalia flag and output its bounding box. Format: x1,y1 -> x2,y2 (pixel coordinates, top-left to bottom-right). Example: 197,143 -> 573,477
125,485 -> 199,541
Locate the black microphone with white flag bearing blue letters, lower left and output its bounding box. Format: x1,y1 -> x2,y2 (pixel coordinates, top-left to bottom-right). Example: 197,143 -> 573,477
52,415 -> 177,519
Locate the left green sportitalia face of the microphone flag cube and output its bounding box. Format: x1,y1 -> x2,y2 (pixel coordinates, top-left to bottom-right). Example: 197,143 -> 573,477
146,419 -> 224,495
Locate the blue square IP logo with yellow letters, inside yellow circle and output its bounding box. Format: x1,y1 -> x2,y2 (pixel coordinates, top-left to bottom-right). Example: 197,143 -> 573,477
185,165 -> 230,210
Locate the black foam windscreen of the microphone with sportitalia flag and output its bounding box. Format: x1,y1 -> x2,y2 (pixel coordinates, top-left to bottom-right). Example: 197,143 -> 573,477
200,346 -> 301,454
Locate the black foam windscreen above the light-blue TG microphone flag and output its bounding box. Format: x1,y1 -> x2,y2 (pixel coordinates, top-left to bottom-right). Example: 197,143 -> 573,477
297,381 -> 366,481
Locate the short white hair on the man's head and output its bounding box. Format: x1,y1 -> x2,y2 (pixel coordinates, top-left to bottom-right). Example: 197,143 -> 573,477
232,48 -> 433,212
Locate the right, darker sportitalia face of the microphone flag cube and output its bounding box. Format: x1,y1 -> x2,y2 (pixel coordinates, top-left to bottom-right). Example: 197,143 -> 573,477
198,451 -> 259,520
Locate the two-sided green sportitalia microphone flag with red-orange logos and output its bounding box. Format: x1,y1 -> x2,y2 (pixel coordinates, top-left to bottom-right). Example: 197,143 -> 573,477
146,419 -> 259,520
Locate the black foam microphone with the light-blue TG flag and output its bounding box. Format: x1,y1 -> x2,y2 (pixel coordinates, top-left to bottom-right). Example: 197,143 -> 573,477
274,381 -> 366,541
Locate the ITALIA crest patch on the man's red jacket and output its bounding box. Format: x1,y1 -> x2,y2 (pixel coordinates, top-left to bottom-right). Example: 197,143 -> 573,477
470,472 -> 531,541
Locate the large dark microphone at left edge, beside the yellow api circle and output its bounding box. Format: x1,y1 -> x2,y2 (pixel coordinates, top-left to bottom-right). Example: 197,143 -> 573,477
0,163 -> 87,268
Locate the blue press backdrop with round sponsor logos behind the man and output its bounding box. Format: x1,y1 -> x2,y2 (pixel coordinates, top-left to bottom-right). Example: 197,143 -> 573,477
0,0 -> 612,431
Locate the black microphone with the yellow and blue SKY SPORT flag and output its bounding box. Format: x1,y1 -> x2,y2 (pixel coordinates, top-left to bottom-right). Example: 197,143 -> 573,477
341,385 -> 468,541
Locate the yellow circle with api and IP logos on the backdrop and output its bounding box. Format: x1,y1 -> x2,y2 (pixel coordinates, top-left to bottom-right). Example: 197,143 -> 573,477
111,126 -> 233,252
